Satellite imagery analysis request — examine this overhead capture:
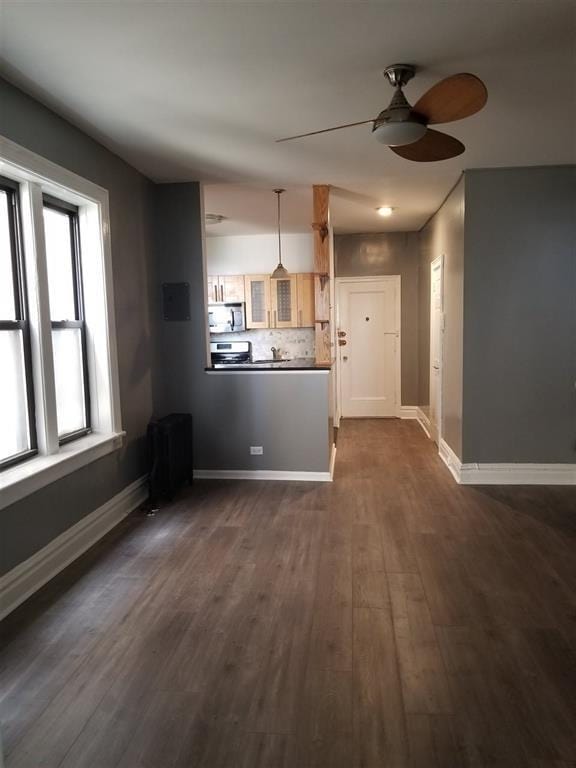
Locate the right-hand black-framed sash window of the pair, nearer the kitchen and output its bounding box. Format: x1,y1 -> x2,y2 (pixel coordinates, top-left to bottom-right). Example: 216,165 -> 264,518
44,195 -> 90,443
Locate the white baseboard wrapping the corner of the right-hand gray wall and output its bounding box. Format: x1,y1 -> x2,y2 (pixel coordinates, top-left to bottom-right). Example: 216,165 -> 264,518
439,440 -> 576,485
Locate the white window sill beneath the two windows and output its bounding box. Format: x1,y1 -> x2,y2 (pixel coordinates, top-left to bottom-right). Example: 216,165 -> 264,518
0,432 -> 126,509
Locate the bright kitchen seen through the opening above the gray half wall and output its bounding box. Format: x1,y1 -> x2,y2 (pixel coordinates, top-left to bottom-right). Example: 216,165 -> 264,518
206,190 -> 330,370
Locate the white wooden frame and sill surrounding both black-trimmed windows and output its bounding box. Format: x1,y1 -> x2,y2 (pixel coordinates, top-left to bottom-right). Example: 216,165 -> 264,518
0,136 -> 125,509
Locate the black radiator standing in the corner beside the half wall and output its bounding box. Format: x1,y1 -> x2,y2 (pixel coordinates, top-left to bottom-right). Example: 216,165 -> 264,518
147,413 -> 194,506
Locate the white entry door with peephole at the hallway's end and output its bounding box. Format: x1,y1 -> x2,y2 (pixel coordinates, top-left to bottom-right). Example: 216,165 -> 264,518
337,275 -> 400,418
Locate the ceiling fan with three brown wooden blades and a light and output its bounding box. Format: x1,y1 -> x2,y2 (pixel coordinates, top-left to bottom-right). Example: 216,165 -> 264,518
277,64 -> 488,163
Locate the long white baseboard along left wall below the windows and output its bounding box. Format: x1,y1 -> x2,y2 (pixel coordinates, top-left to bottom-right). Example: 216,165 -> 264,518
0,477 -> 148,619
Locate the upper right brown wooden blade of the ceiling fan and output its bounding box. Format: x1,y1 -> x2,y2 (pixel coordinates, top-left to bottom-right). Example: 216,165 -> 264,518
414,72 -> 488,125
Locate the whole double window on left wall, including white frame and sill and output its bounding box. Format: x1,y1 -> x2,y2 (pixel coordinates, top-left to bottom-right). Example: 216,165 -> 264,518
0,136 -> 124,508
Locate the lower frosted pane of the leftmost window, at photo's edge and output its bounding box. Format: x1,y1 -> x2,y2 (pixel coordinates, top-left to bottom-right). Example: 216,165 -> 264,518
0,330 -> 30,461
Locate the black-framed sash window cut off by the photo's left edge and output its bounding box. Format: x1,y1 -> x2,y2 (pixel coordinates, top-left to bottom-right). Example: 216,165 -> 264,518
0,177 -> 36,467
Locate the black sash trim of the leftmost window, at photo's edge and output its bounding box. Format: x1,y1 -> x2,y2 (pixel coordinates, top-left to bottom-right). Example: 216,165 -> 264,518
0,176 -> 38,470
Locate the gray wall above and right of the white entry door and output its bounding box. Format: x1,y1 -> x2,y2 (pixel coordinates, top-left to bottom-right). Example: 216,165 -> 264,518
334,232 -> 419,405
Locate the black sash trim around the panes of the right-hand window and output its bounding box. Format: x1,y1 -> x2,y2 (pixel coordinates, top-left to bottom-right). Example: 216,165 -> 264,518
42,194 -> 92,445
